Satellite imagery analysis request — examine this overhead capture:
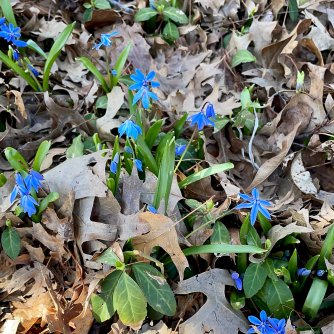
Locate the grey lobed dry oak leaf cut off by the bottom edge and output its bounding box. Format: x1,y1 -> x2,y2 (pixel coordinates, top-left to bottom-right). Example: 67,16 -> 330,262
174,269 -> 249,334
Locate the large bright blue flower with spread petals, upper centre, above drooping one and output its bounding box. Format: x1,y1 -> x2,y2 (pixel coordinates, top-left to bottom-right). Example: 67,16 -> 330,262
129,69 -> 160,109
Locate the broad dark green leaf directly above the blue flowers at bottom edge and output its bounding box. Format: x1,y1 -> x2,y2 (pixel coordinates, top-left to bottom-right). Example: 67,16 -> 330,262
266,279 -> 295,319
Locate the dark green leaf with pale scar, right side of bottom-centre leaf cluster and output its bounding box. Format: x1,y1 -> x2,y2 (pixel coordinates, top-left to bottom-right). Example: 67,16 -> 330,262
132,263 -> 176,316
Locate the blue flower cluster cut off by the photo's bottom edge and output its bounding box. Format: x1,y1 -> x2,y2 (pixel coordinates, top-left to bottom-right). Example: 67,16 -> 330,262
247,311 -> 286,334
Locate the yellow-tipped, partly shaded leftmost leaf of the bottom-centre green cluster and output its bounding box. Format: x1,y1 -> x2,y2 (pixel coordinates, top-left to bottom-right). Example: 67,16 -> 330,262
90,270 -> 122,322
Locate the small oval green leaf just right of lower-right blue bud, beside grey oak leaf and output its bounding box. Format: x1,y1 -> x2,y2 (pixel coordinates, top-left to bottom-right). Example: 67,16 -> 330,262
243,263 -> 267,298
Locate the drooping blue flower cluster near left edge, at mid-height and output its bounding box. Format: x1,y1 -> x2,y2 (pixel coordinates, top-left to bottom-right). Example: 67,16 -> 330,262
10,170 -> 44,217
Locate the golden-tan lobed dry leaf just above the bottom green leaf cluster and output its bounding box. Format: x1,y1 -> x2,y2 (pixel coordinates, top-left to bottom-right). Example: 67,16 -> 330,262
132,212 -> 189,281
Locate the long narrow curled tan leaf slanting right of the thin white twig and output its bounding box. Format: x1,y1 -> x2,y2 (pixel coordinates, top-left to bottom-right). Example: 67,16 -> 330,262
246,121 -> 301,192
